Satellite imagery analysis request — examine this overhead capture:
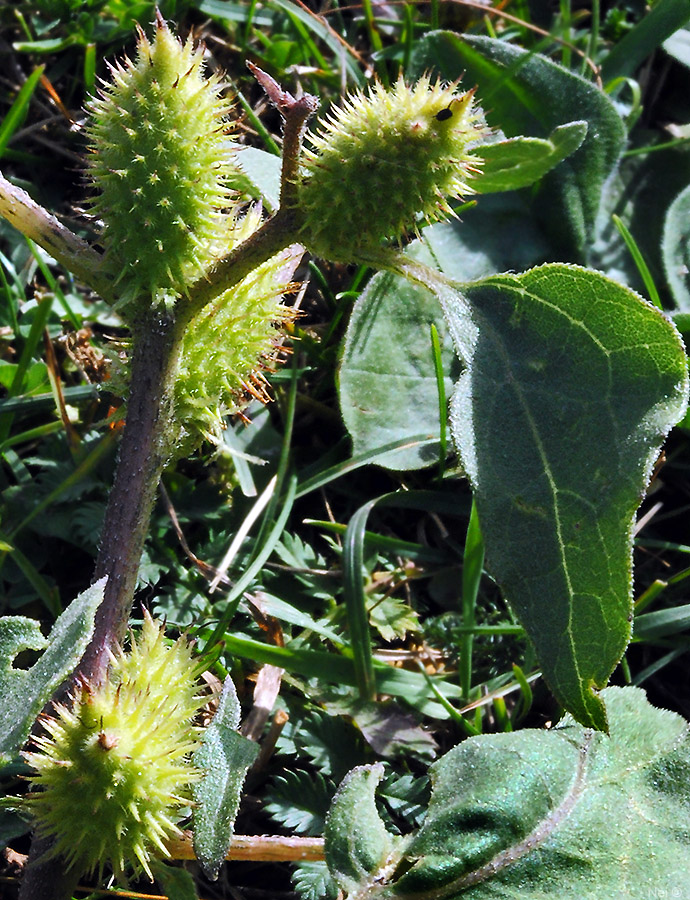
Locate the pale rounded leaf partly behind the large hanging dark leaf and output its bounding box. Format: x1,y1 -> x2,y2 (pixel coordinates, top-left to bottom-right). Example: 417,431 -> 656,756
340,273 -> 460,470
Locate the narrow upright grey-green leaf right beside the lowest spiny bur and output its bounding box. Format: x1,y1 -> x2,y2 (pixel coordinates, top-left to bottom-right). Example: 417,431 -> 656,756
193,676 -> 259,881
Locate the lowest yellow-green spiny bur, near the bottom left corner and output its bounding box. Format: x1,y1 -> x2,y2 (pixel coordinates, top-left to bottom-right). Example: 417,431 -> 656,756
24,615 -> 203,879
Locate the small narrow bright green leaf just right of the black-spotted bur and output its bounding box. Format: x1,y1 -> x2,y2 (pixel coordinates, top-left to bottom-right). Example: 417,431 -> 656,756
472,122 -> 587,194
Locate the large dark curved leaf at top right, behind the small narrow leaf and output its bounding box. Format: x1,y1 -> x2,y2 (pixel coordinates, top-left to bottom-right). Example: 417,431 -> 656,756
412,32 -> 628,258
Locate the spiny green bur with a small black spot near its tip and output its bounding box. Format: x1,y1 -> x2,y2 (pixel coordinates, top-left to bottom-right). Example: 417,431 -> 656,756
298,76 -> 487,262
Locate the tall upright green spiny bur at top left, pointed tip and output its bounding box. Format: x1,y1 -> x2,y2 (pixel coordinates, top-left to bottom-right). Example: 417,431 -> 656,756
87,17 -> 233,306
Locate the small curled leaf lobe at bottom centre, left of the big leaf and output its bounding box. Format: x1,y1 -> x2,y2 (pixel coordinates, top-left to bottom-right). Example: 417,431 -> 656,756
324,763 -> 400,897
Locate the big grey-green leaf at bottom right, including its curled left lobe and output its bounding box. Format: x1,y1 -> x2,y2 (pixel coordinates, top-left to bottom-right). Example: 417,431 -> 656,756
326,687 -> 690,900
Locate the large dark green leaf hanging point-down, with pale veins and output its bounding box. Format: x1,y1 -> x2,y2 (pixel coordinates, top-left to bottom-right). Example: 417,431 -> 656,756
446,265 -> 688,729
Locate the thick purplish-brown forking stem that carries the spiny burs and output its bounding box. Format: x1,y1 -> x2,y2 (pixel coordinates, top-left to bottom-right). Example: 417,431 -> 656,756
16,70 -> 317,900
